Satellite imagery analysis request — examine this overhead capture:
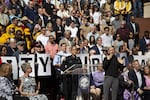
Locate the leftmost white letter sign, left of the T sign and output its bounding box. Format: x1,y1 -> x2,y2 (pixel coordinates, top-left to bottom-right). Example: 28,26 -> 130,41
1,56 -> 18,80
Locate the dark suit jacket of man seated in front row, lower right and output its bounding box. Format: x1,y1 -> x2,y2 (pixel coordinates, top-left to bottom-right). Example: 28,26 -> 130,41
128,70 -> 146,91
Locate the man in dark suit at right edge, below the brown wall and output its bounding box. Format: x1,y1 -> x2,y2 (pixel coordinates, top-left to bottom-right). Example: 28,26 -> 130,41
139,31 -> 150,54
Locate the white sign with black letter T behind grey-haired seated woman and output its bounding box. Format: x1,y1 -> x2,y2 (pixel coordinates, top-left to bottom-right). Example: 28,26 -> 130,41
19,54 -> 35,77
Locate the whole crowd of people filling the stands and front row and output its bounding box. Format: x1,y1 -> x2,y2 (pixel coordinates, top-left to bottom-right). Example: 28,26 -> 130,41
0,0 -> 150,100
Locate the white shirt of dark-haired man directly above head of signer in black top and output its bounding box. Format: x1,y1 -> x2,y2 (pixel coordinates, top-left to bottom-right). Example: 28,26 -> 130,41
101,33 -> 113,47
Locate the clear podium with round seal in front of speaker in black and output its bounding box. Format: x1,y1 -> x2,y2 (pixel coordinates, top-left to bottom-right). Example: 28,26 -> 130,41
62,64 -> 101,100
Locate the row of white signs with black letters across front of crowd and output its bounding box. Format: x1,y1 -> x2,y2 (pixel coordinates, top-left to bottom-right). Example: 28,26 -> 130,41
1,54 -> 150,80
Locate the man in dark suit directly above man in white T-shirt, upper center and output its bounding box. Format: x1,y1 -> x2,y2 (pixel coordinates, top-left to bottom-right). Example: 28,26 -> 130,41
66,10 -> 80,27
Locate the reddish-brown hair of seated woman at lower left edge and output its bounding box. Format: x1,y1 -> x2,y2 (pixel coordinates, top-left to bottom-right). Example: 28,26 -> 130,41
0,63 -> 12,77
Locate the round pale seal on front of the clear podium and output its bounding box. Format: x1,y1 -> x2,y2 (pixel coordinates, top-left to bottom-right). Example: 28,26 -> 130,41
79,76 -> 90,89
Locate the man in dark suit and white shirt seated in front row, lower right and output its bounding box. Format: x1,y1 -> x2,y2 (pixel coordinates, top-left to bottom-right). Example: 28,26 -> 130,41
128,60 -> 146,100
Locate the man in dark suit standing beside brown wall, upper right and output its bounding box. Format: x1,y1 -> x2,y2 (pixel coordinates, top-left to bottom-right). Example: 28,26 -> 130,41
128,16 -> 140,45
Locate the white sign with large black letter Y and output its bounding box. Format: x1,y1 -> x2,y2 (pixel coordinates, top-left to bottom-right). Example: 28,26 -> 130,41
37,54 -> 51,76
